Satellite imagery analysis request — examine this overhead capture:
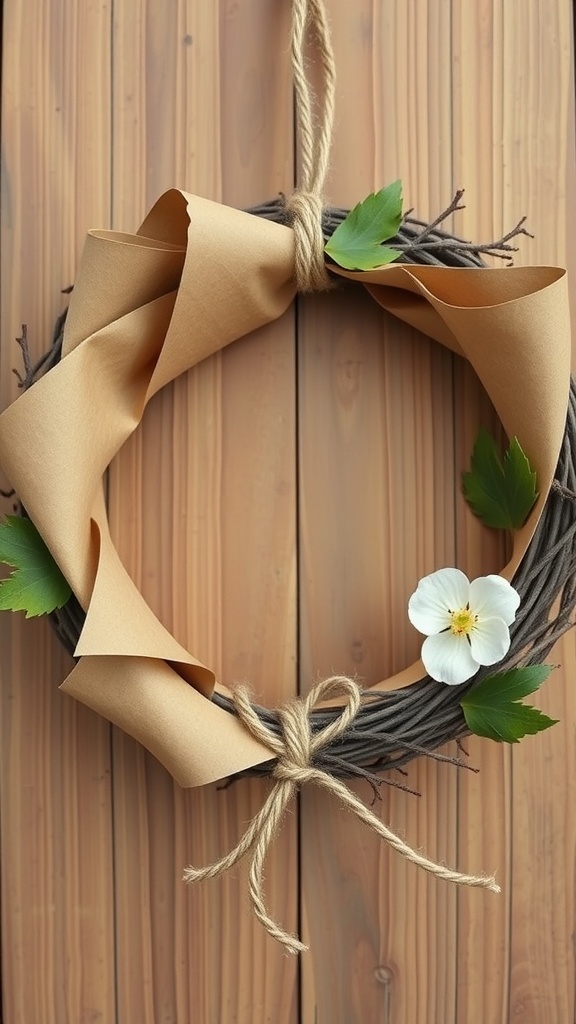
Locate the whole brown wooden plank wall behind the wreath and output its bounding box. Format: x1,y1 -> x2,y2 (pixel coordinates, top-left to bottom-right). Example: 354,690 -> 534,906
0,0 -> 576,1024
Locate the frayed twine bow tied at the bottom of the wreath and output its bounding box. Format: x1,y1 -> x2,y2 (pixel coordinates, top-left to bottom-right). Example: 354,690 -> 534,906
183,676 -> 500,953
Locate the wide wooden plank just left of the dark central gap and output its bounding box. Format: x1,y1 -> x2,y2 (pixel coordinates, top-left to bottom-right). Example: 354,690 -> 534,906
105,0 -> 297,1024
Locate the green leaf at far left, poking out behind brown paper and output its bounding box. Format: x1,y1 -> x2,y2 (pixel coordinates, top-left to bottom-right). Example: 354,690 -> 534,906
0,515 -> 72,618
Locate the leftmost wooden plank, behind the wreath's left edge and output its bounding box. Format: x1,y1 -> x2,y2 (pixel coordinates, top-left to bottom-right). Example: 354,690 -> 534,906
0,0 -> 116,1024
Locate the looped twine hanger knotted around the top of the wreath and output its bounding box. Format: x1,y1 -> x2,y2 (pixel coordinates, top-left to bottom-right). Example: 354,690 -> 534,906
285,0 -> 336,292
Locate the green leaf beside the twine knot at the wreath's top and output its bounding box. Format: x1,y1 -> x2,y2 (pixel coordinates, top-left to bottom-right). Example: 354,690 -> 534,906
324,181 -> 402,270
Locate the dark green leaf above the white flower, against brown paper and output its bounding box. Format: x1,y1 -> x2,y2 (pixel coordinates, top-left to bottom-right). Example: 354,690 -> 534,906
462,428 -> 538,529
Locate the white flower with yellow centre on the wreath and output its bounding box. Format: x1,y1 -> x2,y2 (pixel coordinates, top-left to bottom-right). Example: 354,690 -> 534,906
408,568 -> 520,686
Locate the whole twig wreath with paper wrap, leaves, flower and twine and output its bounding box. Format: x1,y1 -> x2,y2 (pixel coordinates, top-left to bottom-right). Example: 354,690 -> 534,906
0,0 -> 576,952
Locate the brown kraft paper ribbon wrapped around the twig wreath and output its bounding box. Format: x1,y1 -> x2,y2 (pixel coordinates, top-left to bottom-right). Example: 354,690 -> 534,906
0,189 -> 570,786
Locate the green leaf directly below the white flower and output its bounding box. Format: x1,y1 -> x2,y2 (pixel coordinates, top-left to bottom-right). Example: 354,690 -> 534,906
460,665 -> 557,743
